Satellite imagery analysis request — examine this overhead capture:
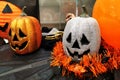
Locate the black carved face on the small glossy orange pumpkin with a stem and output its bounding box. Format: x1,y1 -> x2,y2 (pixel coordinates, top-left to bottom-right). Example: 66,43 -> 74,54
9,28 -> 28,50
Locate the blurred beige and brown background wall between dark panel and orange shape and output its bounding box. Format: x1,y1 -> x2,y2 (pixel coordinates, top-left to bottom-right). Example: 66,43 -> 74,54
39,0 -> 95,29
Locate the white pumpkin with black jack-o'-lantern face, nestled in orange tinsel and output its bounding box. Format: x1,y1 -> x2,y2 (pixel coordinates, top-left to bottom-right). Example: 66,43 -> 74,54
63,17 -> 101,60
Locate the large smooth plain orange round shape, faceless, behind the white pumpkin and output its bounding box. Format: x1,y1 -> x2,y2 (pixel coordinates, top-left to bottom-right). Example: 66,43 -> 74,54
93,0 -> 120,49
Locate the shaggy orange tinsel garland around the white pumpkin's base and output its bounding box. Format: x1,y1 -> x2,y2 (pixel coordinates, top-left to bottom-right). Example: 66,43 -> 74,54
51,41 -> 120,77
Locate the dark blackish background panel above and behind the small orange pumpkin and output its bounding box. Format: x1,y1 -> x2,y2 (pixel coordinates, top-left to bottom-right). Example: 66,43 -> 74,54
6,0 -> 39,20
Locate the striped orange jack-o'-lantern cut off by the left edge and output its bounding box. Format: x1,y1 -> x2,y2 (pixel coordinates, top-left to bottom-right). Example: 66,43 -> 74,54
0,1 -> 22,38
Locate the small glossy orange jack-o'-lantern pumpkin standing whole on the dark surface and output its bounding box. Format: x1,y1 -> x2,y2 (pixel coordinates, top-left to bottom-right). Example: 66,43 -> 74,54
9,11 -> 42,54
